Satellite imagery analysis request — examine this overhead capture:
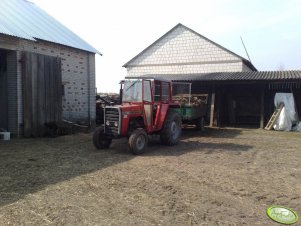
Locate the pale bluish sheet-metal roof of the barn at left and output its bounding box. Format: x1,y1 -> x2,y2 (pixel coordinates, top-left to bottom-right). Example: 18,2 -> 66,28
0,0 -> 101,54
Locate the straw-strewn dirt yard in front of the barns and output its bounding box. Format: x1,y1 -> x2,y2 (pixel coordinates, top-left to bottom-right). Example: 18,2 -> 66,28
0,128 -> 301,225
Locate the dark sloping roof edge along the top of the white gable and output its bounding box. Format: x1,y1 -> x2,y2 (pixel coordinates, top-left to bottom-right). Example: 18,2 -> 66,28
123,23 -> 257,71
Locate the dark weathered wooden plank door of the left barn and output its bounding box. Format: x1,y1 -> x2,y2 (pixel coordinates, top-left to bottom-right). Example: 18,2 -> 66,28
22,52 -> 62,137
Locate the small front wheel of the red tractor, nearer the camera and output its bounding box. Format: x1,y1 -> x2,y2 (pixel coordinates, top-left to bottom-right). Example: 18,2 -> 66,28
129,129 -> 148,155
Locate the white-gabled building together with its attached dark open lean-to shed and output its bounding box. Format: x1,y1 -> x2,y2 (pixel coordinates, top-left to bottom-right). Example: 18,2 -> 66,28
124,24 -> 301,128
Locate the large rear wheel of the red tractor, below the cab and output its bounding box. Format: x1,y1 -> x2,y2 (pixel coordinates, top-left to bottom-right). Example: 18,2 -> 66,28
160,112 -> 182,146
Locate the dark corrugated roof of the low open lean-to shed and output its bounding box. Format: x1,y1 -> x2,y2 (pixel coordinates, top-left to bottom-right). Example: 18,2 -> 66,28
131,71 -> 301,82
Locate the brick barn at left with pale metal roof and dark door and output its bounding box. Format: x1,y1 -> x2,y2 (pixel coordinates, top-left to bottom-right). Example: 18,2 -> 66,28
0,0 -> 100,137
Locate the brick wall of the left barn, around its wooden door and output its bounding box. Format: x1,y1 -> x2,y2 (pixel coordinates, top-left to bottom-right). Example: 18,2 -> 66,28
0,35 -> 95,135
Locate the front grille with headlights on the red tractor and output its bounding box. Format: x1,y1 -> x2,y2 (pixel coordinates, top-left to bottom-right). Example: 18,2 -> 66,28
104,107 -> 120,135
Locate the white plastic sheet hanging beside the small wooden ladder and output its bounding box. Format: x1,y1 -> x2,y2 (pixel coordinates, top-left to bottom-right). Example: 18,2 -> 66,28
274,93 -> 297,131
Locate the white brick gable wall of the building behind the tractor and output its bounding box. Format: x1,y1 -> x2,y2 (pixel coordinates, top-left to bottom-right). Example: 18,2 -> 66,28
126,26 -> 243,76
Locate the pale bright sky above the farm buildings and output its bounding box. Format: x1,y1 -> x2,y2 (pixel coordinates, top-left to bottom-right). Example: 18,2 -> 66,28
30,0 -> 301,92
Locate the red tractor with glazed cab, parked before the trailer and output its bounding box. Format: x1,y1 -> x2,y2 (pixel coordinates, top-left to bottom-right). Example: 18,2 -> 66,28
93,77 -> 182,154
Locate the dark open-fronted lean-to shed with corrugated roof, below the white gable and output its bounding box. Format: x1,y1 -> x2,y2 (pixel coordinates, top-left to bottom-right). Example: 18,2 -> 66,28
135,71 -> 301,128
